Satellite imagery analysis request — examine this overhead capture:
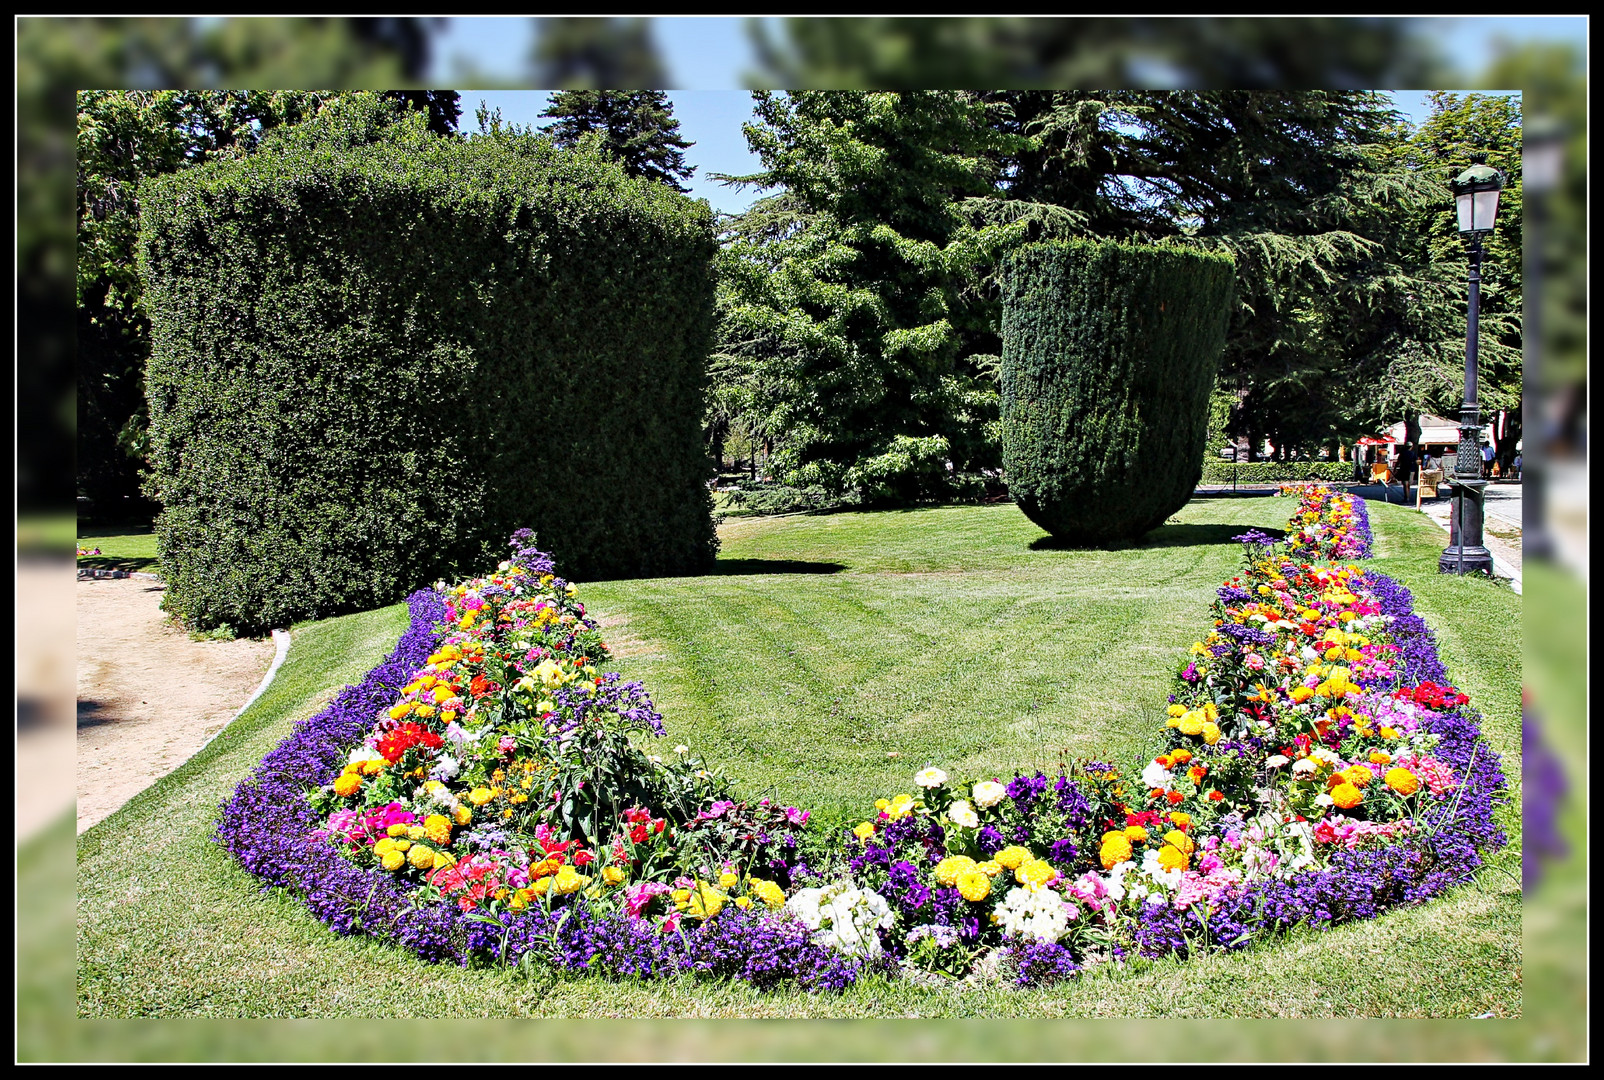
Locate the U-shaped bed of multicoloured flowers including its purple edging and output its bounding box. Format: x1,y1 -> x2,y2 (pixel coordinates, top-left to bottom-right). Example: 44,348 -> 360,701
218,491 -> 1505,989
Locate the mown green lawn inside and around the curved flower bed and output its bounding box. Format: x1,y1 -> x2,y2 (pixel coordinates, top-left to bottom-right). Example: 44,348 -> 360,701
65,499 -> 1522,1020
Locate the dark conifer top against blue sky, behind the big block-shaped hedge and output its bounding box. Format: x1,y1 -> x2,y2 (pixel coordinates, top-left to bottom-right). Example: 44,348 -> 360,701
541,90 -> 696,194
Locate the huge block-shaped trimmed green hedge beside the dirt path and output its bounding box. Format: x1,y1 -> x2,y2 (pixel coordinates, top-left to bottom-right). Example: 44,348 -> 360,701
140,99 -> 717,631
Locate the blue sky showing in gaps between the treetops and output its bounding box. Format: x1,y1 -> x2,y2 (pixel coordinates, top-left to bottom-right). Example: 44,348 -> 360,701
433,16 -> 1586,213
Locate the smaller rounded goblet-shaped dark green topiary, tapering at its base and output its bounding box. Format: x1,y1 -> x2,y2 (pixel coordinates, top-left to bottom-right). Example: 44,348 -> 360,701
1001,241 -> 1235,544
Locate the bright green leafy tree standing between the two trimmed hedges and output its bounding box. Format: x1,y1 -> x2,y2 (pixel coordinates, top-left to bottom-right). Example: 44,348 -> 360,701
711,93 -> 1028,502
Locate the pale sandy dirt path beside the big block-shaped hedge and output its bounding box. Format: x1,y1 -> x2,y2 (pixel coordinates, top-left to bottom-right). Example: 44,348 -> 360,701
77,578 -> 273,833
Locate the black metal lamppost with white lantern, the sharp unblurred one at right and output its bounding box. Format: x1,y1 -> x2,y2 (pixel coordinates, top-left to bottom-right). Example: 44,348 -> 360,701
1437,165 -> 1505,576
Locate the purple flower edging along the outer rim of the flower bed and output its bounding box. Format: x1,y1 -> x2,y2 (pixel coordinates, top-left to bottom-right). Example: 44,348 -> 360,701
217,497 -> 1506,989
